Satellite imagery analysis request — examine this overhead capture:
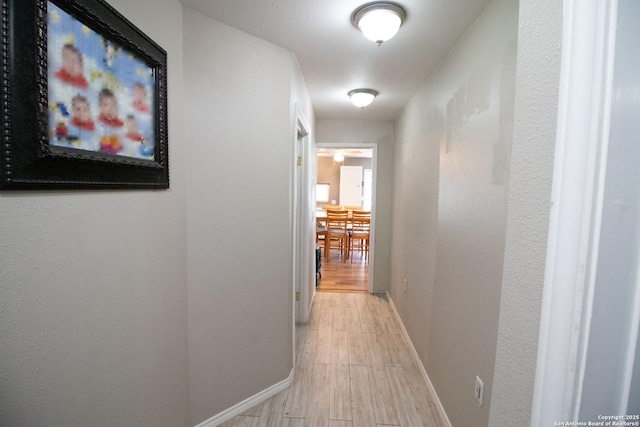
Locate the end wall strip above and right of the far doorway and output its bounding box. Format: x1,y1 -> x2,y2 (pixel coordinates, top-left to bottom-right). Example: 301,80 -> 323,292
316,120 -> 393,293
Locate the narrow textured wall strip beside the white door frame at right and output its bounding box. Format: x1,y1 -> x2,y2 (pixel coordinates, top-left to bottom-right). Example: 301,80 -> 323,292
489,0 -> 563,426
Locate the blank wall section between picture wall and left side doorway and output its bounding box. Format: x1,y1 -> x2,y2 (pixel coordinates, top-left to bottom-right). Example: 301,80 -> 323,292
184,9 -> 313,424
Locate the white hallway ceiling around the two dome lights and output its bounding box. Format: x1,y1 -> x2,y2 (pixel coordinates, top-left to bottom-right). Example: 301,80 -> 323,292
181,0 -> 490,120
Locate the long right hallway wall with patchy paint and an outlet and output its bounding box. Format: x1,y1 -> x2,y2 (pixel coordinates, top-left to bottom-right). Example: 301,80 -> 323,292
389,0 -> 518,426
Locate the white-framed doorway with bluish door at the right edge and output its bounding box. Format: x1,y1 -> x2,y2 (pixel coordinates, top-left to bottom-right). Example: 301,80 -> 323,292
531,0 -> 640,425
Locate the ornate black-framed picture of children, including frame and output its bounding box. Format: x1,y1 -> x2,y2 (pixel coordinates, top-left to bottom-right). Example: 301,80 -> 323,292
0,0 -> 169,190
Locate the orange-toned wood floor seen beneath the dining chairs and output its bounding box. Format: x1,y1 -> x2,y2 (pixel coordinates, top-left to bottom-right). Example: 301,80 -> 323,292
316,251 -> 369,292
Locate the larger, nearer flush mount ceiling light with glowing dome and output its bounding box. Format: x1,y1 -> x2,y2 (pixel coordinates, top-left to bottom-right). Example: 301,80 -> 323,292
351,2 -> 407,46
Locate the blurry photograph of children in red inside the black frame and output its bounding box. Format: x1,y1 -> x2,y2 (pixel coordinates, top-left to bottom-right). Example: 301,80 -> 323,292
47,1 -> 156,160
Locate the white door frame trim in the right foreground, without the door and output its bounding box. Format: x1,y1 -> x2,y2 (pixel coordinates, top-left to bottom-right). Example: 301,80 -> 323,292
531,0 -> 617,427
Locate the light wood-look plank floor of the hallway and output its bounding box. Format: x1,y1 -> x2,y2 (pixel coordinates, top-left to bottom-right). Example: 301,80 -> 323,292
223,293 -> 444,427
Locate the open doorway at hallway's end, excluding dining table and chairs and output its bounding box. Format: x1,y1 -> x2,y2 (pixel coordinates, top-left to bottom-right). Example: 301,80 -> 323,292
315,143 -> 377,293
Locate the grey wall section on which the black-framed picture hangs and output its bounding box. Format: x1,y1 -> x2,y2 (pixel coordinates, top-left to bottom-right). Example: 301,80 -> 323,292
0,0 -> 189,427
